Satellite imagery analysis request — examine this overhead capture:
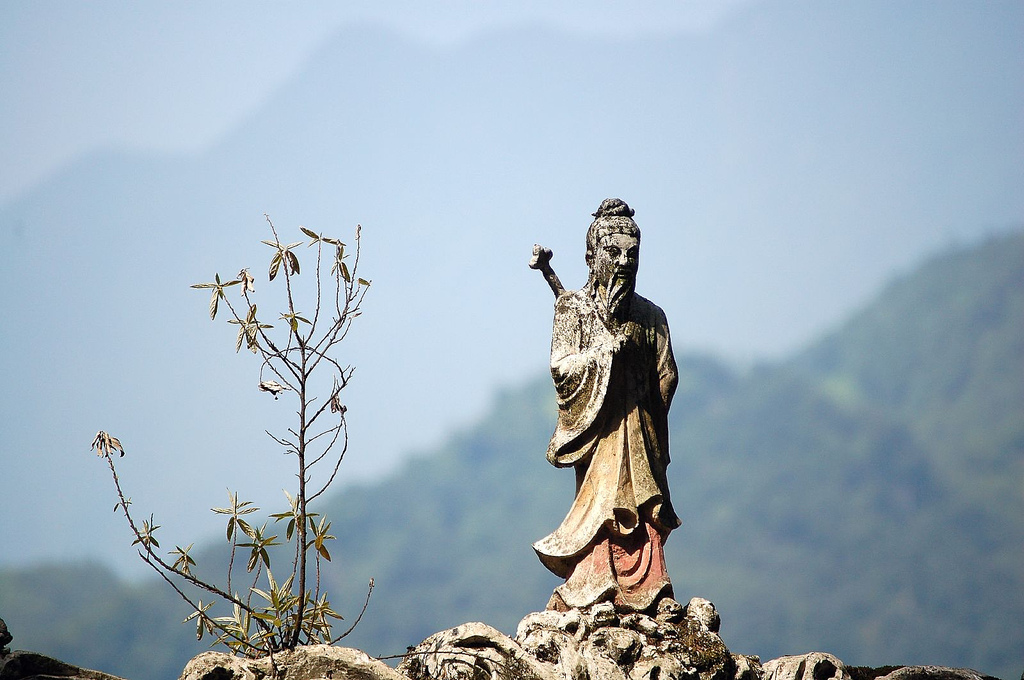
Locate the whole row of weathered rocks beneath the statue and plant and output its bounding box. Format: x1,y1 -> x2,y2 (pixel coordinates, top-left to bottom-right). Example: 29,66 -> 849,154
0,597 -> 1003,680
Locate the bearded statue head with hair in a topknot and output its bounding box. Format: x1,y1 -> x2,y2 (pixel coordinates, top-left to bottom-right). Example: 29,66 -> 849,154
587,199 -> 640,312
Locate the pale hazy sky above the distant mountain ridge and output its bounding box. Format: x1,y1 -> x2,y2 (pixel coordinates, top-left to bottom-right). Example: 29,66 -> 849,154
0,0 -> 754,204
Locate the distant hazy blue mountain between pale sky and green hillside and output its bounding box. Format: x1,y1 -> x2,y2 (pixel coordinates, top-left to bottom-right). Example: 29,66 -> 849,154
0,3 -> 1024,568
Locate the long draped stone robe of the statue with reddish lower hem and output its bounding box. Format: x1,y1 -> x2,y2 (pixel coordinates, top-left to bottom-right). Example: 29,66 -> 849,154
534,287 -> 680,611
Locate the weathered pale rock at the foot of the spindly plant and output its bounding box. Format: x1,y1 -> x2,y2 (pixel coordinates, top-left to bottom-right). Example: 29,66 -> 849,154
178,644 -> 404,680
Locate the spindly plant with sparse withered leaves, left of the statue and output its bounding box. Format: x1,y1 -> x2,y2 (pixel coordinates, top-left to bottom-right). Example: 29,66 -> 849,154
92,215 -> 374,656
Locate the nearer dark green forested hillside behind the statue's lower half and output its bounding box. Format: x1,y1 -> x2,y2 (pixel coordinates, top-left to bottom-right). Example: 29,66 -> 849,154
0,229 -> 1024,680
